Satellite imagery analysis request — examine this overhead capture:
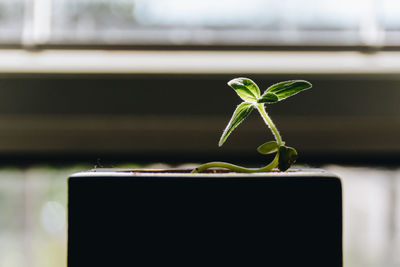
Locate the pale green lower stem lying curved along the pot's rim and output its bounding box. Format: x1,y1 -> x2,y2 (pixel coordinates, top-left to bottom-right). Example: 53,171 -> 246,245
192,153 -> 279,173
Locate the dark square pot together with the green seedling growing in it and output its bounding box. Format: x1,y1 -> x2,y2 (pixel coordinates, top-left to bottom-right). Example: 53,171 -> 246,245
68,78 -> 343,267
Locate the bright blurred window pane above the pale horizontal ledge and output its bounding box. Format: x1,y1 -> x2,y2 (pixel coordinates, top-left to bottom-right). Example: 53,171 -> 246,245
0,0 -> 400,47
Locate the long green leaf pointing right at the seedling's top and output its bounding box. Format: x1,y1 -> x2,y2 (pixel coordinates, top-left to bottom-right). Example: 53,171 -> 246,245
262,80 -> 312,101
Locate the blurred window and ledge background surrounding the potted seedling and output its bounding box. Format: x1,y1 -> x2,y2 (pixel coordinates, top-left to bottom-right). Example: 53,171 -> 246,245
0,0 -> 400,267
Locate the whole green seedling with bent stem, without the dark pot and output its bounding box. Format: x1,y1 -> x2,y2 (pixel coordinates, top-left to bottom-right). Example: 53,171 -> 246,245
192,78 -> 312,173
